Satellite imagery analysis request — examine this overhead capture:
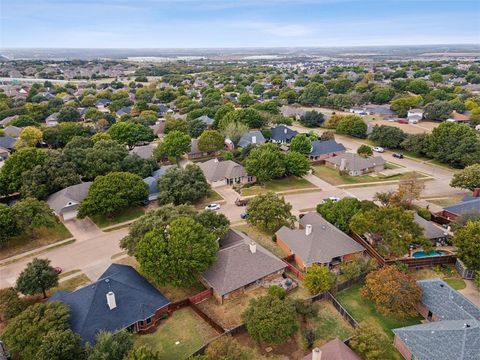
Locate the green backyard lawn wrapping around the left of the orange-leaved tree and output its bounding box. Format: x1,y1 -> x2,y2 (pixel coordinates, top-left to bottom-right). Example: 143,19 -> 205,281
336,284 -> 423,359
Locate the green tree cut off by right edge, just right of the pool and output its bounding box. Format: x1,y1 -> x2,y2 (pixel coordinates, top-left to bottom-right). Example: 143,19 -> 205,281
453,220 -> 480,270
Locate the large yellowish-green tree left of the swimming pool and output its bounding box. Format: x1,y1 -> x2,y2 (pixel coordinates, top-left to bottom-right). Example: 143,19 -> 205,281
350,206 -> 431,256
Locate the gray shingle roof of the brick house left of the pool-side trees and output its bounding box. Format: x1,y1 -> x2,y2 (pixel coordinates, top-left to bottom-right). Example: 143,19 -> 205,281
276,212 -> 365,266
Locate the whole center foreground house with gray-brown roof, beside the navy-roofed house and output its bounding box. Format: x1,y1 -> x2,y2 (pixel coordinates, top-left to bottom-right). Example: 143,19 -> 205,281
202,230 -> 287,303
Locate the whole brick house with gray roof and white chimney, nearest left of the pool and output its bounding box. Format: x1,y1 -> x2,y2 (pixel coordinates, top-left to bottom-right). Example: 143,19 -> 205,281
275,212 -> 365,271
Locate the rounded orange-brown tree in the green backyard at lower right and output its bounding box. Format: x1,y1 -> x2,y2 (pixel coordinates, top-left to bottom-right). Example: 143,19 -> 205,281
360,265 -> 422,319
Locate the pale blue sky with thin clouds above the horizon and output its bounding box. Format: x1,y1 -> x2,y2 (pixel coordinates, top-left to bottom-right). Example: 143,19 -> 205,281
0,0 -> 480,48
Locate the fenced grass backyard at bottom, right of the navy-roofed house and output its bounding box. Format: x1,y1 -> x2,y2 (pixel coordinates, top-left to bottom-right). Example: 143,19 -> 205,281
134,307 -> 219,360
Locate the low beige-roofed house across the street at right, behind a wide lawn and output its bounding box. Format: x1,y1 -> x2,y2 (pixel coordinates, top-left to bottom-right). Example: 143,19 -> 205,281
325,153 -> 385,176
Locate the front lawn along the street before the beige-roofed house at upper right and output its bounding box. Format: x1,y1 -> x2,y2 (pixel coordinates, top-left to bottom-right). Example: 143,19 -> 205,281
313,165 -> 423,185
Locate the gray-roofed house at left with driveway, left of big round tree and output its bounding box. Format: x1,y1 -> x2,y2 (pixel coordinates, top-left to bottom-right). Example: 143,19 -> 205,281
47,182 -> 92,221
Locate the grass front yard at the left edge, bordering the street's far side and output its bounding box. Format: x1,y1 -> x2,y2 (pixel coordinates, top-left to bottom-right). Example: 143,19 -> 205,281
0,222 -> 72,260
